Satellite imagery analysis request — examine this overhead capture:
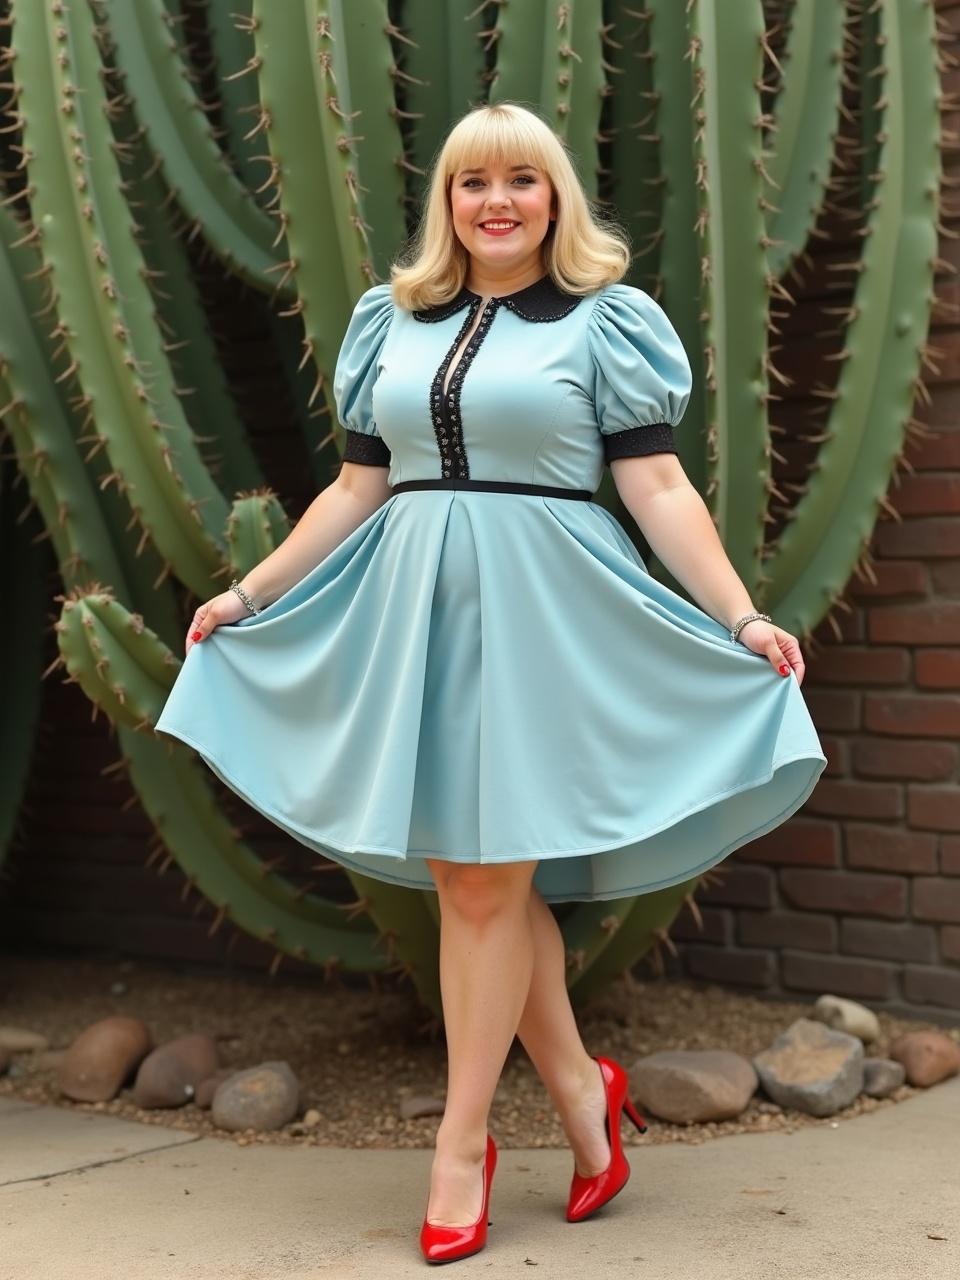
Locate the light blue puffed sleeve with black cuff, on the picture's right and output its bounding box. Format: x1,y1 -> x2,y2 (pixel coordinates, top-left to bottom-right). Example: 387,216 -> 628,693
588,283 -> 692,462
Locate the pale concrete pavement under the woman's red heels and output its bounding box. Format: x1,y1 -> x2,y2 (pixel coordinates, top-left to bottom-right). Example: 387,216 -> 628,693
0,1076 -> 960,1280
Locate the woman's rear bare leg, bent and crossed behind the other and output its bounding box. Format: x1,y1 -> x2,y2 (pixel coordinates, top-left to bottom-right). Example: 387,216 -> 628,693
517,886 -> 611,1178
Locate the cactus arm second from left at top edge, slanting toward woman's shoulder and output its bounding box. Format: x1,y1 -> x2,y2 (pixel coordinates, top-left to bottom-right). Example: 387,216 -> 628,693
95,0 -> 294,302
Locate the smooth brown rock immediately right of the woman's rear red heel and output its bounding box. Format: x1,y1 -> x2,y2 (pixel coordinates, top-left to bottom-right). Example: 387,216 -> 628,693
630,1048 -> 756,1124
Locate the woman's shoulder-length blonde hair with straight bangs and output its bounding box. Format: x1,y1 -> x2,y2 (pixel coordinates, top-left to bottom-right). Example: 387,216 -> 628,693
390,102 -> 631,311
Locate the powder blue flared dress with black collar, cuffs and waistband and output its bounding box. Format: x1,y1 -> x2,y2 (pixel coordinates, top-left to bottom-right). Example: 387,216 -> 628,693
156,275 -> 827,902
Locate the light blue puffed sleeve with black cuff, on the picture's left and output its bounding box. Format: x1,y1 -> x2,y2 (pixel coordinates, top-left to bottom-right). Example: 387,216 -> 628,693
333,283 -> 394,467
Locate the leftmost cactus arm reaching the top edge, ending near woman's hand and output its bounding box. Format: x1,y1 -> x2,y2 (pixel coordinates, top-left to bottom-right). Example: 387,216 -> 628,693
13,0 -> 227,594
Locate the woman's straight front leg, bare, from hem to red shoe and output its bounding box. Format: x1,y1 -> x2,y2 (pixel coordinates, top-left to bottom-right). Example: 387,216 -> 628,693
426,859 -> 536,1226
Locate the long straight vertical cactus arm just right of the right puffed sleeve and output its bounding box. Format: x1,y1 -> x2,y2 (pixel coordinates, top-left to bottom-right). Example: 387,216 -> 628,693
687,0 -> 771,593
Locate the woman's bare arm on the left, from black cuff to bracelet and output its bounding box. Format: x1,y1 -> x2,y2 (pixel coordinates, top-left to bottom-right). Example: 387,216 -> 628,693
241,462 -> 393,607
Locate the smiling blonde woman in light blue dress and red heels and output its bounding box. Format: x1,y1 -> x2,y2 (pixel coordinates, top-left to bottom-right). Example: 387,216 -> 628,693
157,104 -> 826,1262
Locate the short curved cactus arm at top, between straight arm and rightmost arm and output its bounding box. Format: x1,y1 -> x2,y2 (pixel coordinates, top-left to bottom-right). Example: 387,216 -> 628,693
765,4 -> 845,279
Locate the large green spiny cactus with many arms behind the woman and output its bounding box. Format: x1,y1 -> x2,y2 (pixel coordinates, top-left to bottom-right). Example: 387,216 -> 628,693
0,0 -> 946,1014
